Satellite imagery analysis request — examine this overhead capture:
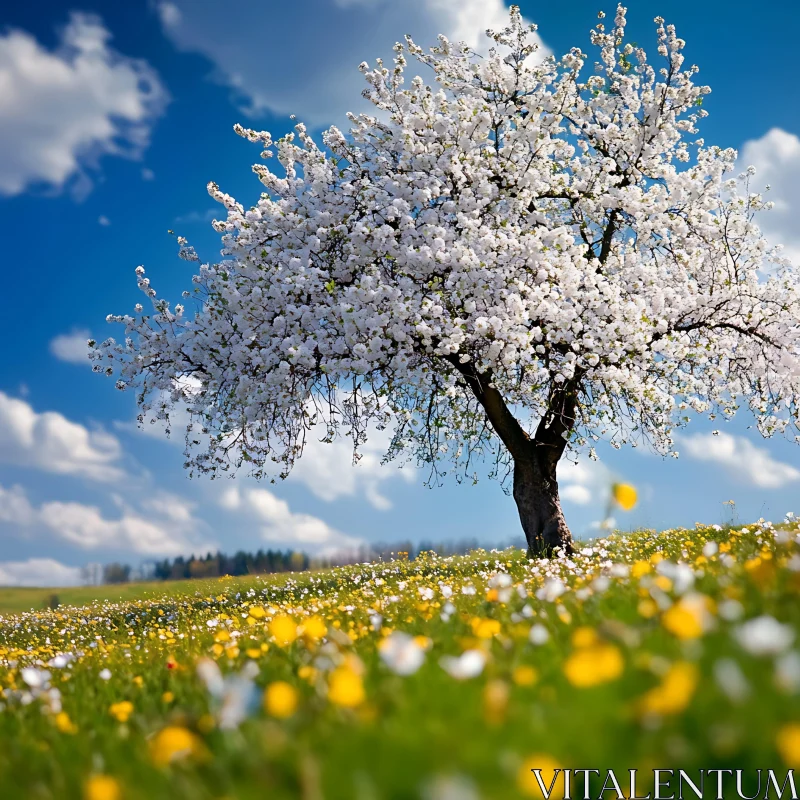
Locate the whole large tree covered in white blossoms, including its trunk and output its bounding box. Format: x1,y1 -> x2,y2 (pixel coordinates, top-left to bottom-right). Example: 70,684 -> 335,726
93,7 -> 800,553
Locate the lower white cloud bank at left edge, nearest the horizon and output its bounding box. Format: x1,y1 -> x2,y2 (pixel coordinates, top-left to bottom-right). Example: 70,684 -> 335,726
0,486 -> 216,556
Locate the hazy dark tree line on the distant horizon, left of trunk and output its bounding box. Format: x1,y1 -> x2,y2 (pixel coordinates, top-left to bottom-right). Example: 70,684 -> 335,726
92,540 -> 494,583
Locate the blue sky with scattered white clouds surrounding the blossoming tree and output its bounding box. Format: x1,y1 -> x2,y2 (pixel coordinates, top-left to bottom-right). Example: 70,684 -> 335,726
0,0 -> 800,584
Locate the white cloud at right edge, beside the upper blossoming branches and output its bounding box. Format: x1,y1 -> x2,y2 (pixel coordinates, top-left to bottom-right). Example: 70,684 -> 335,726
736,128 -> 800,266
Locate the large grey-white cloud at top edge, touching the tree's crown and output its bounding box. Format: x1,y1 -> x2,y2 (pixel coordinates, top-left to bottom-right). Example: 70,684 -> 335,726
158,0 -> 544,126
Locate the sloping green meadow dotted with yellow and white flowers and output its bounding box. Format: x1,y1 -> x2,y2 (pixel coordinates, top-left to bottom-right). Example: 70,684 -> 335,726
0,518 -> 800,800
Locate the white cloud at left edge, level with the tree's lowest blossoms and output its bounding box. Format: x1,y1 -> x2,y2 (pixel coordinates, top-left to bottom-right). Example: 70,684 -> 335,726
0,392 -> 125,483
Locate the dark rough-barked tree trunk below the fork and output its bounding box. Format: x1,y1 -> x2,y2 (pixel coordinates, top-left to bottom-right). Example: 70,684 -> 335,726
514,442 -> 572,558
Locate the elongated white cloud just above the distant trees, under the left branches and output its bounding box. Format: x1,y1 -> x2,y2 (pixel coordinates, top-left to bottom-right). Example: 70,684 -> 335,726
219,486 -> 362,555
